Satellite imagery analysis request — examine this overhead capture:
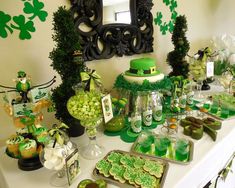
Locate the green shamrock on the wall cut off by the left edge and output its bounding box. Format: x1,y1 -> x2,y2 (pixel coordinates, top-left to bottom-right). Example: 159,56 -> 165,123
0,11 -> 13,38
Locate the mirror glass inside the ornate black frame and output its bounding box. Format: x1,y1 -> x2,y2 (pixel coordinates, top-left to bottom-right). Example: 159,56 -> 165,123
103,0 -> 131,25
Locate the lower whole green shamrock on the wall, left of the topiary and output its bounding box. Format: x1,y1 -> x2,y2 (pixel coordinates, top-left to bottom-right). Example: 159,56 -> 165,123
11,15 -> 36,40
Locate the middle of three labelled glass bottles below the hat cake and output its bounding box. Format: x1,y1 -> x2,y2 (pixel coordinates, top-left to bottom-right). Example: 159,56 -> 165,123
143,94 -> 153,127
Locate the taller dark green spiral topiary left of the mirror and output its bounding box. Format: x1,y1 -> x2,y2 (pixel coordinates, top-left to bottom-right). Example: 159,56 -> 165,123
49,7 -> 85,136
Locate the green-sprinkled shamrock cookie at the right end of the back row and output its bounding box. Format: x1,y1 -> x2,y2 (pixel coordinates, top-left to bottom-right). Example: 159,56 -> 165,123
143,160 -> 164,178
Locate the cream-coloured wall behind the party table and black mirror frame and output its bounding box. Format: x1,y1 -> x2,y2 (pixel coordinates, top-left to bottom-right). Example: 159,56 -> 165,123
0,0 -> 235,143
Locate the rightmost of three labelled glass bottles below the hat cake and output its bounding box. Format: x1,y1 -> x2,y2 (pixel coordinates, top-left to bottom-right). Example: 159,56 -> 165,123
152,92 -> 162,121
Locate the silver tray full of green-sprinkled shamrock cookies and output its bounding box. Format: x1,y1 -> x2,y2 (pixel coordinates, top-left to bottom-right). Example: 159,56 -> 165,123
93,150 -> 169,188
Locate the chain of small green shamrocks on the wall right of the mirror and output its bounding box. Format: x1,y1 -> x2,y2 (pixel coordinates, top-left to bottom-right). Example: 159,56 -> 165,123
154,0 -> 178,35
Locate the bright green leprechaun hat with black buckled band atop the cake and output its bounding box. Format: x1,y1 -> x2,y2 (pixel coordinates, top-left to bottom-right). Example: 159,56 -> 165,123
125,58 -> 160,77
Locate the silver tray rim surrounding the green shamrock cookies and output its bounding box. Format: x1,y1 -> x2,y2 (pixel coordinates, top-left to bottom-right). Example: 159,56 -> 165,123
93,150 -> 169,188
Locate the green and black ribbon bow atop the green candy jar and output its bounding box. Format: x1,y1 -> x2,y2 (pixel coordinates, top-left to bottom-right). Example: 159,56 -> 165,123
80,70 -> 101,91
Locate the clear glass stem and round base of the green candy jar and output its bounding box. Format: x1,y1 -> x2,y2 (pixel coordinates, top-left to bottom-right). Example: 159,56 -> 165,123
81,117 -> 105,160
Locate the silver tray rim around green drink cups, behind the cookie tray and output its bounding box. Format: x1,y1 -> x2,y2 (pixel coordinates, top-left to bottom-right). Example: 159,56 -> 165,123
131,133 -> 194,165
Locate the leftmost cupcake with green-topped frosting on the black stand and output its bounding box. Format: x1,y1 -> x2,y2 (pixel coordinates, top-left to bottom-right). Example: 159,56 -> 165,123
6,135 -> 24,157
